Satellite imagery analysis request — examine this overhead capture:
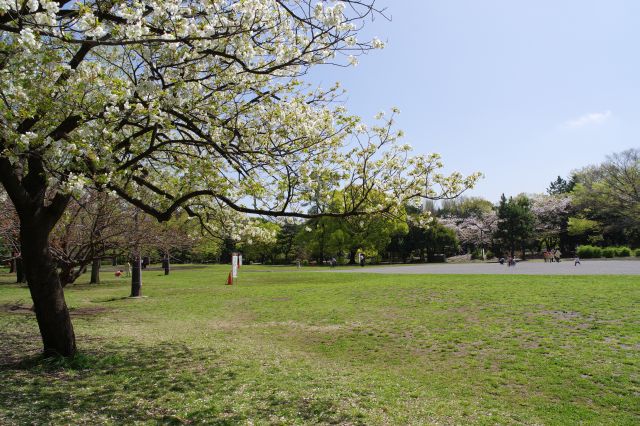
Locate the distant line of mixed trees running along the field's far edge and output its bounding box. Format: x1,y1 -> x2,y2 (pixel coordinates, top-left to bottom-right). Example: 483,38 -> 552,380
0,149 -> 640,274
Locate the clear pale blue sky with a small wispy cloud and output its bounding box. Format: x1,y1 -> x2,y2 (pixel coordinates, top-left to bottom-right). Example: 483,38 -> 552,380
312,0 -> 640,201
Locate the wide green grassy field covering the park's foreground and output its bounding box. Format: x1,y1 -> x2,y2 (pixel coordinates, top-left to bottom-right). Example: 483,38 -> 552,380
0,266 -> 640,425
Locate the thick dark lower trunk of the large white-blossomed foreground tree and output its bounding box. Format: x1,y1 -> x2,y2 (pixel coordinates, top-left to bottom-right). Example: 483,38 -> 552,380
20,218 -> 76,357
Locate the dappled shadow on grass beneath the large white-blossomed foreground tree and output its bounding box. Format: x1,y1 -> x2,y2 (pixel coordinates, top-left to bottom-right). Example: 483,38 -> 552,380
0,326 -> 361,425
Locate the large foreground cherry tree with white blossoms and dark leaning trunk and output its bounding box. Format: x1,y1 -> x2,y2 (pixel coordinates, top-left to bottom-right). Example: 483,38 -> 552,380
0,0 -> 477,356
